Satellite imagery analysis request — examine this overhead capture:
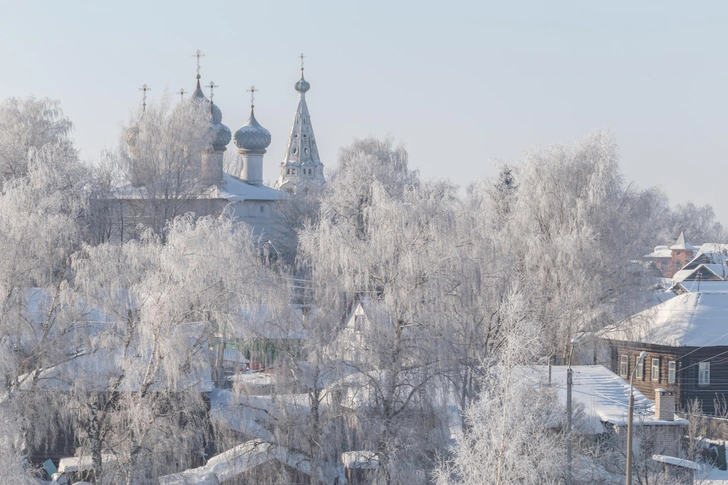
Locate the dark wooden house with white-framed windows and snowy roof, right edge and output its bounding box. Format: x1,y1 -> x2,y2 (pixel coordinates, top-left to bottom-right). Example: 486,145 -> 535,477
602,290 -> 728,414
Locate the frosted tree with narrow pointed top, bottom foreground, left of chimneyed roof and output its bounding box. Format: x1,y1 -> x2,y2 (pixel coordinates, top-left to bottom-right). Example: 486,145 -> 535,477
436,288 -> 565,485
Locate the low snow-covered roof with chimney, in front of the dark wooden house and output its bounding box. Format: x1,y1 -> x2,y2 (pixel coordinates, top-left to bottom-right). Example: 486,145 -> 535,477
523,365 -> 688,434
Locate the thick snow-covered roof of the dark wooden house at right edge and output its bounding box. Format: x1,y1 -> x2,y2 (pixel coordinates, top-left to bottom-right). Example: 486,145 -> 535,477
601,290 -> 728,347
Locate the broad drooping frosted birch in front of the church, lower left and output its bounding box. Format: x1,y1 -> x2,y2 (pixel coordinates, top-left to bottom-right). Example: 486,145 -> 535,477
69,214 -> 265,484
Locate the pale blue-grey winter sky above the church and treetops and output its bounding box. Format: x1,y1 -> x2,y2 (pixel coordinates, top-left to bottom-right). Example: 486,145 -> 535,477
0,0 -> 728,224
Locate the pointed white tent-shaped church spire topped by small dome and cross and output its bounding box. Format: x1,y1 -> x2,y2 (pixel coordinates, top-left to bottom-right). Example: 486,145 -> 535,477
275,54 -> 324,192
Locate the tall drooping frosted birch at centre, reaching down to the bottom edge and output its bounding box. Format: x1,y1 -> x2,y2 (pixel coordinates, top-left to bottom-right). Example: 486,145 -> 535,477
300,140 -> 454,483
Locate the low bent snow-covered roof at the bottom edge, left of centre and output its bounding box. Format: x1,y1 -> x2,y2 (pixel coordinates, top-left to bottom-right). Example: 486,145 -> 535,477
159,440 -> 311,485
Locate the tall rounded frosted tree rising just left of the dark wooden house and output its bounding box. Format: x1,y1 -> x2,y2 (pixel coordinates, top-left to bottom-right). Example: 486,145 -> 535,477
498,132 -> 663,356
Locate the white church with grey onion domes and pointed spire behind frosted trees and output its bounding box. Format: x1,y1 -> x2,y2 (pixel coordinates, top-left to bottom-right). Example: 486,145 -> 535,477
99,55 -> 324,241
